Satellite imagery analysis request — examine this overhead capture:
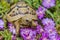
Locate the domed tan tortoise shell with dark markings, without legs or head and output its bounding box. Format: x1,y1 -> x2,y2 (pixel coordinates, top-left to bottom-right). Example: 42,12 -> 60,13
7,2 -> 37,22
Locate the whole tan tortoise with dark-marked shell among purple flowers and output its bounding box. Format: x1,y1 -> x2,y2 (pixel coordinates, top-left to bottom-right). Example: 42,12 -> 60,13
6,1 -> 37,34
